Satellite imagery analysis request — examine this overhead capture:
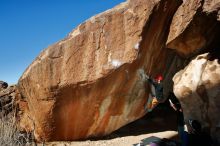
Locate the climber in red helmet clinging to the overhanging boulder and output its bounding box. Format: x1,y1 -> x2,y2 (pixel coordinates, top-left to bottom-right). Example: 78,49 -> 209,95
144,74 -> 164,112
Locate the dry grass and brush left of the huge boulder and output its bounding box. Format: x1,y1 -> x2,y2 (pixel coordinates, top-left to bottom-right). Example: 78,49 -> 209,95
0,86 -> 34,146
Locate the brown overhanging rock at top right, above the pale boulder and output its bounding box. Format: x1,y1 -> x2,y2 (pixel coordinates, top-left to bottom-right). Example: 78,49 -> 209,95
167,0 -> 220,57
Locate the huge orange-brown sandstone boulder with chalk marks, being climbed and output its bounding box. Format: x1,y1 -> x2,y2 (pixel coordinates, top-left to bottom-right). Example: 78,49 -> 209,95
18,0 -> 182,141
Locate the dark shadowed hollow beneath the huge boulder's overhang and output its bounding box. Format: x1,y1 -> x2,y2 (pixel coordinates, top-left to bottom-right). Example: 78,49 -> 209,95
93,102 -> 177,140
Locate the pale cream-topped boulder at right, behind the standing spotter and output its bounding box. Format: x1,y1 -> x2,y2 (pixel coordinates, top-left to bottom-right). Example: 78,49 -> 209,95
173,54 -> 220,142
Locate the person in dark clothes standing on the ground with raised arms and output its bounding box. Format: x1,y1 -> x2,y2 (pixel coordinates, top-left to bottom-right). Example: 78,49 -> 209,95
168,92 -> 187,146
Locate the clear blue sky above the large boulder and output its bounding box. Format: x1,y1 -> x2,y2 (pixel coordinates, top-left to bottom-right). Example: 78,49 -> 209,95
0,0 -> 125,84
